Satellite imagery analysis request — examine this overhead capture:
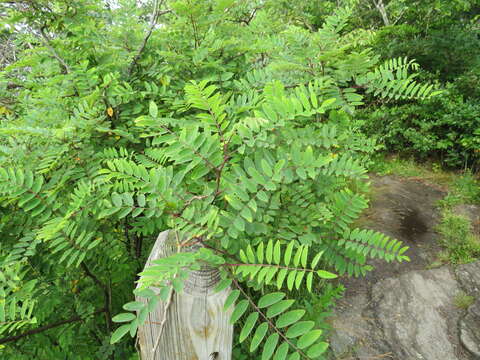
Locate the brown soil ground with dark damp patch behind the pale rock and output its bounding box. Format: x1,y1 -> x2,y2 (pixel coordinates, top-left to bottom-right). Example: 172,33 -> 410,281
342,176 -> 446,298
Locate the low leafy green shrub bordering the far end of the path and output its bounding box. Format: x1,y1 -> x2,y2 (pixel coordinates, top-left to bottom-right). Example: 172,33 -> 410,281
362,87 -> 480,168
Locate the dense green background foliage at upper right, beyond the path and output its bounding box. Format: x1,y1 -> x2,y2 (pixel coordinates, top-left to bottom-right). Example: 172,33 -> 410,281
362,0 -> 480,169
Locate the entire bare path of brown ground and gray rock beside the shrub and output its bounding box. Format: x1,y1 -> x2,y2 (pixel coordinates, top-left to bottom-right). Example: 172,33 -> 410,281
330,176 -> 480,360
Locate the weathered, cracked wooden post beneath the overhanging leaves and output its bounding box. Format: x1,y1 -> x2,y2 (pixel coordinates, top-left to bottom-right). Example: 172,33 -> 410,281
136,230 -> 233,360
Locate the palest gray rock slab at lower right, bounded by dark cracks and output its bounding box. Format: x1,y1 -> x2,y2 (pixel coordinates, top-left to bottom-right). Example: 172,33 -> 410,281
372,268 -> 460,360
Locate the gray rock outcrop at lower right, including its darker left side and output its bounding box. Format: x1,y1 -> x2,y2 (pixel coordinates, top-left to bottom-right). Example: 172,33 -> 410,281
331,267 -> 470,360
